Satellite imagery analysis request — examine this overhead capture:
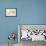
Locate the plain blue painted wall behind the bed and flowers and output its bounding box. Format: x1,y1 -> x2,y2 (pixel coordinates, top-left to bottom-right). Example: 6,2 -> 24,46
0,0 -> 46,44
